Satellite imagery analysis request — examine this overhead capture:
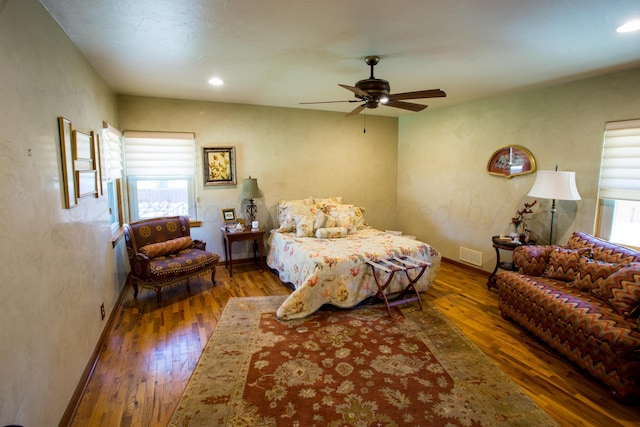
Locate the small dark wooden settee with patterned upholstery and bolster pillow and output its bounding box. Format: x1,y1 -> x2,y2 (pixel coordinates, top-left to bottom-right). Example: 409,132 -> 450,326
124,216 -> 220,306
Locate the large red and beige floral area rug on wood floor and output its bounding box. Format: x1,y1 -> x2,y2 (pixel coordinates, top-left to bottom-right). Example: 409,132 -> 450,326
169,296 -> 557,427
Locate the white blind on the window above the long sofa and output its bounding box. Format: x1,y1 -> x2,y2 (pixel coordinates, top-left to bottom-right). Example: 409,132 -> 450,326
599,120 -> 640,201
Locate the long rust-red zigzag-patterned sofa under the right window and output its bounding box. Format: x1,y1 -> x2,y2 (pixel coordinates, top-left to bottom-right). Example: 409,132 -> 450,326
496,232 -> 640,402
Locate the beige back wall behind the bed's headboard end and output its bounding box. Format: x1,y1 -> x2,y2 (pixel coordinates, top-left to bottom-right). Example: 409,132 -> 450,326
118,96 -> 398,258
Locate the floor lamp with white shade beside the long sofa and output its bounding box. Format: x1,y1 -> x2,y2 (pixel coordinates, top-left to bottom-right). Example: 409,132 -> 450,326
528,166 -> 580,245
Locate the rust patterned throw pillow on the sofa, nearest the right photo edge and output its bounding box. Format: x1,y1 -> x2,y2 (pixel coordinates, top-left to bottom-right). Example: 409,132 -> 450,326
591,262 -> 640,317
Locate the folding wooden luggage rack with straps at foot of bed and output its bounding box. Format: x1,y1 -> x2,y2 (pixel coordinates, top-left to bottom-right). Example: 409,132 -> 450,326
367,255 -> 431,317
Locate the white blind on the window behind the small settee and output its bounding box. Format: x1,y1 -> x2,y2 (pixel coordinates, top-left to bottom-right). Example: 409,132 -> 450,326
124,131 -> 196,176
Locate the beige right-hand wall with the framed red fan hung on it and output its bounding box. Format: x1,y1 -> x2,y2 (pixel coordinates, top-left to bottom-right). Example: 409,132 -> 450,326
398,69 -> 640,270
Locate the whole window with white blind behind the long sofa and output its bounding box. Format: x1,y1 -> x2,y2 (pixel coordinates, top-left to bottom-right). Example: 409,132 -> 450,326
596,120 -> 640,247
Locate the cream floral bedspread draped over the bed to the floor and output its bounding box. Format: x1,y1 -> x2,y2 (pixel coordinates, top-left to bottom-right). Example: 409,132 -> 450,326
267,228 -> 441,319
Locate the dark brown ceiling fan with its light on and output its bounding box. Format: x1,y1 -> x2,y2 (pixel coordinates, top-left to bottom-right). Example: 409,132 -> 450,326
301,56 -> 447,116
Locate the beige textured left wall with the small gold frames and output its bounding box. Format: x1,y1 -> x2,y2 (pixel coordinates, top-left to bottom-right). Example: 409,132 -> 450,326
0,0 -> 119,426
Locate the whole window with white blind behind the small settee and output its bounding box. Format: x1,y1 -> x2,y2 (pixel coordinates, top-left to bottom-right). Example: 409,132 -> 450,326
124,131 -> 196,221
